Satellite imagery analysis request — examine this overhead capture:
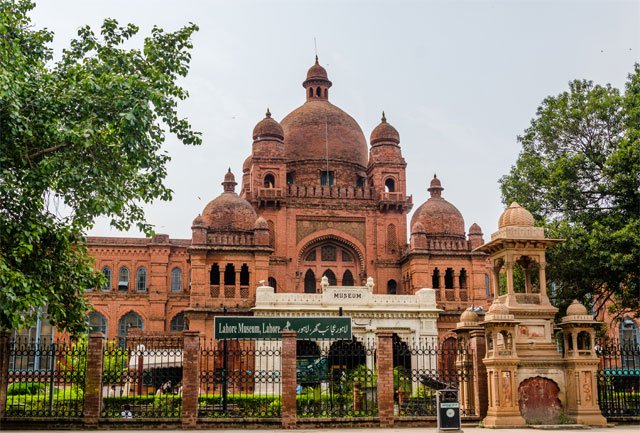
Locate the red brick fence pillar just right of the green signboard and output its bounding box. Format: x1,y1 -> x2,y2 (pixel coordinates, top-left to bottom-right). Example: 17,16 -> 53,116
376,331 -> 394,428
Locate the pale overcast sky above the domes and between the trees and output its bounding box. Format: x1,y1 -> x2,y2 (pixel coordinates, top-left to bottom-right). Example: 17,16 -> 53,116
31,0 -> 640,240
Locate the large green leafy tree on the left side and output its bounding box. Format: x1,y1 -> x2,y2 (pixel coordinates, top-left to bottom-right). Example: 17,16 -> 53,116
0,0 -> 201,334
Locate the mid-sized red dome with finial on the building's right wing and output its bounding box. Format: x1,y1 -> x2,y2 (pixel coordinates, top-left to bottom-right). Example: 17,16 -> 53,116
411,175 -> 465,239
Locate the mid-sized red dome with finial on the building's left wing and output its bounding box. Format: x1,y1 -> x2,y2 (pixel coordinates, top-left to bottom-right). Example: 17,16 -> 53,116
202,169 -> 258,231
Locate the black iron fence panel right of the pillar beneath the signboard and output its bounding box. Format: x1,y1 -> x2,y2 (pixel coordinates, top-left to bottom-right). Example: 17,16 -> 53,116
296,338 -> 378,418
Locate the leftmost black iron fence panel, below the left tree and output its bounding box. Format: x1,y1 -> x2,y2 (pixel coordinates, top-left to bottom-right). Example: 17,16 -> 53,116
6,337 -> 87,418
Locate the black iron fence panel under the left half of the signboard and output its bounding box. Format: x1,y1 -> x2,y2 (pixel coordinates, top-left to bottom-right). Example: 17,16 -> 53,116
198,340 -> 282,418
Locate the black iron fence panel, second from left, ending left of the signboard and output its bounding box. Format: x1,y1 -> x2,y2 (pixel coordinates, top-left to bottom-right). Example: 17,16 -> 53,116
101,336 -> 183,418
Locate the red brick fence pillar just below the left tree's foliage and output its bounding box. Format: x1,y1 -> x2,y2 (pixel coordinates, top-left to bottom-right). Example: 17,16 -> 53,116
84,332 -> 104,427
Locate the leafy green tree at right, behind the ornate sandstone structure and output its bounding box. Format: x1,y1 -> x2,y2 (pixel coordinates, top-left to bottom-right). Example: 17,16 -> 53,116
500,64 -> 640,317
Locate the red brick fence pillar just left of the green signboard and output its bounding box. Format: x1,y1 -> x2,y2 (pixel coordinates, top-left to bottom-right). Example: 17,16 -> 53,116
182,331 -> 200,429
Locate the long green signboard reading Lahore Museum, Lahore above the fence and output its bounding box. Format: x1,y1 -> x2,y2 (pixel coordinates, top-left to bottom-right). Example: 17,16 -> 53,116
214,316 -> 351,340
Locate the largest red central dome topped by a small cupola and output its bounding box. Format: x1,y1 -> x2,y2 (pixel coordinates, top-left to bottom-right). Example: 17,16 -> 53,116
280,58 -> 368,167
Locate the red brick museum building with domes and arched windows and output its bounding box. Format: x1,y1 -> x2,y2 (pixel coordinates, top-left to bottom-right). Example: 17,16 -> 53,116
88,59 -> 490,338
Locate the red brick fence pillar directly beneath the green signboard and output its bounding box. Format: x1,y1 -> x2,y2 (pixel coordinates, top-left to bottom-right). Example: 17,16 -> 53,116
280,331 -> 297,428
